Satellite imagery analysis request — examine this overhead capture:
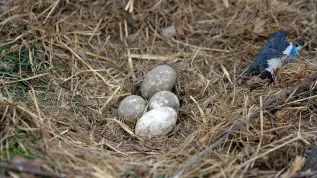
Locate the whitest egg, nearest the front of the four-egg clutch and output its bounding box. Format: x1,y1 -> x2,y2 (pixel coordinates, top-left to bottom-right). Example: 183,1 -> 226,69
135,107 -> 177,139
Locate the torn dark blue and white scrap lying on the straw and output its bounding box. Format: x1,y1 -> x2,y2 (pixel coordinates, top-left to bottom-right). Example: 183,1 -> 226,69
241,31 -> 304,79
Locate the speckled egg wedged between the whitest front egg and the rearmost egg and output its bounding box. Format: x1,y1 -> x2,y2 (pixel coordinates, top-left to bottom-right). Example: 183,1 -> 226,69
149,91 -> 179,110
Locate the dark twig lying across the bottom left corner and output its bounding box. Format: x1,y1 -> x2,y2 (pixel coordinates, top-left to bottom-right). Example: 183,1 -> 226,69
0,163 -> 66,178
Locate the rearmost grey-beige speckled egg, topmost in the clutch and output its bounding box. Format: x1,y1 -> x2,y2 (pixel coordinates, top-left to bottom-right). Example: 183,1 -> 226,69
141,65 -> 176,99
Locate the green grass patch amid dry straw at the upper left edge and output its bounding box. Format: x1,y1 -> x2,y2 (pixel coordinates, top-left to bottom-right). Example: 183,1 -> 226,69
0,44 -> 57,106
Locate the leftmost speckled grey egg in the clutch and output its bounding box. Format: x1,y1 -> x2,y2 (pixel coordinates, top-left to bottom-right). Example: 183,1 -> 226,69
118,95 -> 146,121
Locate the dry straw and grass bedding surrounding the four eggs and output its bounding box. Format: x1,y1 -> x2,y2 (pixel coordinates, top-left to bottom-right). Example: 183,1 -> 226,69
0,0 -> 317,178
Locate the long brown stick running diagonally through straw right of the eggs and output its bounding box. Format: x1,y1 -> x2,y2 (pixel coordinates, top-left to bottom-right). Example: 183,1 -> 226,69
171,73 -> 317,178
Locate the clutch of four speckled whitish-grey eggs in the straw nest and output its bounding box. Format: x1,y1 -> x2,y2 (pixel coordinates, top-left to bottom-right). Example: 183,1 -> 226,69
118,65 -> 180,139
